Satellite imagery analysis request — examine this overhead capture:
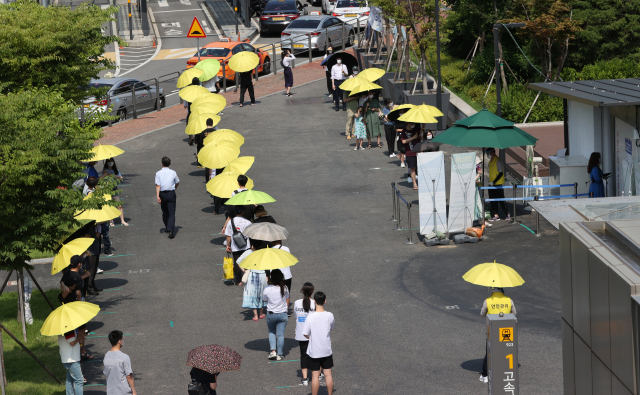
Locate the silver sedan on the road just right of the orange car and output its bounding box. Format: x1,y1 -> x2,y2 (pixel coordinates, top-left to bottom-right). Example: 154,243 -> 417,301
280,15 -> 355,53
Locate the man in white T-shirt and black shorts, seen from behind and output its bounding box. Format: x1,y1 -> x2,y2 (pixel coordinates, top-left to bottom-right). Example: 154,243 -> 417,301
302,291 -> 335,395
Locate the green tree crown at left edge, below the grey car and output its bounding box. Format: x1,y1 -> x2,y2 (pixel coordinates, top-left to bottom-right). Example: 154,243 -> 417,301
0,89 -> 115,269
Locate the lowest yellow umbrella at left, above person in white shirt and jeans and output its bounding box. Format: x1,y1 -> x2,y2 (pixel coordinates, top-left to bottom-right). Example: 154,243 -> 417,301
40,301 -> 100,336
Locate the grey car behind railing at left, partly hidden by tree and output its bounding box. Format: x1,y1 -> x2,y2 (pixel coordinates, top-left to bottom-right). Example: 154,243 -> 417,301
78,78 -> 165,121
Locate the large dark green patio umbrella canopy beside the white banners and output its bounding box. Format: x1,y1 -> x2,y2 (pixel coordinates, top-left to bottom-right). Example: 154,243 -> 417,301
432,109 -> 538,149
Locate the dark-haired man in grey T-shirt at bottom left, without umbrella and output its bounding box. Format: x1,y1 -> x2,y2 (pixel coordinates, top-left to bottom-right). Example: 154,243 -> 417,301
102,331 -> 136,395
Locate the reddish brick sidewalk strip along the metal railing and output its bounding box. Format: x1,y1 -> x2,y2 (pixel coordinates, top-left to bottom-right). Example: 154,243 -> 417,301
97,59 -> 332,144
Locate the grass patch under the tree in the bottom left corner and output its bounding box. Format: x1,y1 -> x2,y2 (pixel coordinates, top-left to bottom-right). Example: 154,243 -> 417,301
0,288 -> 66,395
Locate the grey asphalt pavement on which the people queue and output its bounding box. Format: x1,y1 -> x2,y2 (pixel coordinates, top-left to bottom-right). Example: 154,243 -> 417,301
30,81 -> 562,395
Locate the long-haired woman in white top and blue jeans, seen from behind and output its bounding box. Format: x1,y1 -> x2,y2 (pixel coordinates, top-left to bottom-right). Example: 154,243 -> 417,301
262,269 -> 289,361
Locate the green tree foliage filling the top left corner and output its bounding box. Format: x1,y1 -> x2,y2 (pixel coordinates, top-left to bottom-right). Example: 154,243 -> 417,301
0,0 -> 119,102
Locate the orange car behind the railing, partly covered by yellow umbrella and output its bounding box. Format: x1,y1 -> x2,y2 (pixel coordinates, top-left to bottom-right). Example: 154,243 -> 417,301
187,38 -> 271,83
